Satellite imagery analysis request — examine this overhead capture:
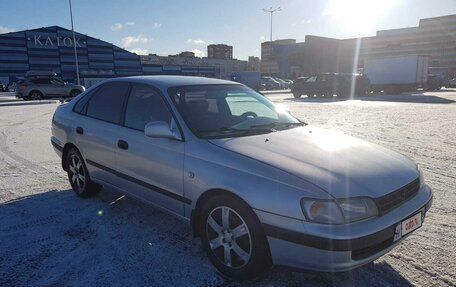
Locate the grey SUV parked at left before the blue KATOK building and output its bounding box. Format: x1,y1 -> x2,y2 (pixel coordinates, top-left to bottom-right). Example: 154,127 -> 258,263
16,71 -> 85,101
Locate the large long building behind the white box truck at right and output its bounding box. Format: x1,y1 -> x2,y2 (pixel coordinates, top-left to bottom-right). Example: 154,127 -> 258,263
261,15 -> 456,78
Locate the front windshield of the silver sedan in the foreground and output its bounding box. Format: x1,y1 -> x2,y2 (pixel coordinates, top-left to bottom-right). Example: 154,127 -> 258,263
168,85 -> 304,138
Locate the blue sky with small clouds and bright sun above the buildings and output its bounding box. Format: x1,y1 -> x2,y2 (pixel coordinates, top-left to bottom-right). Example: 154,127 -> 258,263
0,0 -> 456,59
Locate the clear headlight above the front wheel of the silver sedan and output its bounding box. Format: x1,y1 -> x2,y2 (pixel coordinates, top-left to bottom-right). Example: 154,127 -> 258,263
301,197 -> 378,224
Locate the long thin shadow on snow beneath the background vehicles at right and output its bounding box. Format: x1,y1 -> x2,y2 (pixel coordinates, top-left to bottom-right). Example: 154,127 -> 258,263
284,92 -> 455,104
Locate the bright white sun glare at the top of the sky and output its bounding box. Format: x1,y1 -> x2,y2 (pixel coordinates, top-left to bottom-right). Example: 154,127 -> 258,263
323,0 -> 397,36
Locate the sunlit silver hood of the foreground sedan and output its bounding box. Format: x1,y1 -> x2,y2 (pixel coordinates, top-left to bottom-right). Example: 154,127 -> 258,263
209,126 -> 419,198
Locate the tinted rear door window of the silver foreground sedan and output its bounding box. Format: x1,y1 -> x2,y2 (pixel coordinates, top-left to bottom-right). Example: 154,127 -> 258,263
86,82 -> 129,124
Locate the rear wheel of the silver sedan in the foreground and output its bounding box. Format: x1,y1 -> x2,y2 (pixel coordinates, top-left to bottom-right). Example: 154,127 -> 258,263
66,148 -> 101,197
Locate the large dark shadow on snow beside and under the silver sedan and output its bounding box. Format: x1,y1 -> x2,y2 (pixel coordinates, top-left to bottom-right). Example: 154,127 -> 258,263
0,189 -> 411,286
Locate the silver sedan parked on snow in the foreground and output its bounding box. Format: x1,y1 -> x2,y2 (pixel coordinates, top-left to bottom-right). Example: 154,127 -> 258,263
51,76 -> 432,279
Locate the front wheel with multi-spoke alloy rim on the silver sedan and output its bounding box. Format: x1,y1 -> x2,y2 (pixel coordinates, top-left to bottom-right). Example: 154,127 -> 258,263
199,195 -> 272,280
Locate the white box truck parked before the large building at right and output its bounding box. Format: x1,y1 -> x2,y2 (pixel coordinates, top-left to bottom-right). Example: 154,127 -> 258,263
363,55 -> 429,93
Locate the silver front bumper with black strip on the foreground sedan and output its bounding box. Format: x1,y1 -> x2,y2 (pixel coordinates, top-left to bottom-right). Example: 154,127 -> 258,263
257,186 -> 432,272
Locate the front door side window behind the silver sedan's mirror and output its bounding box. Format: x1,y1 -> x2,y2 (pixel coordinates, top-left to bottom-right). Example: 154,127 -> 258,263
125,85 -> 172,131
